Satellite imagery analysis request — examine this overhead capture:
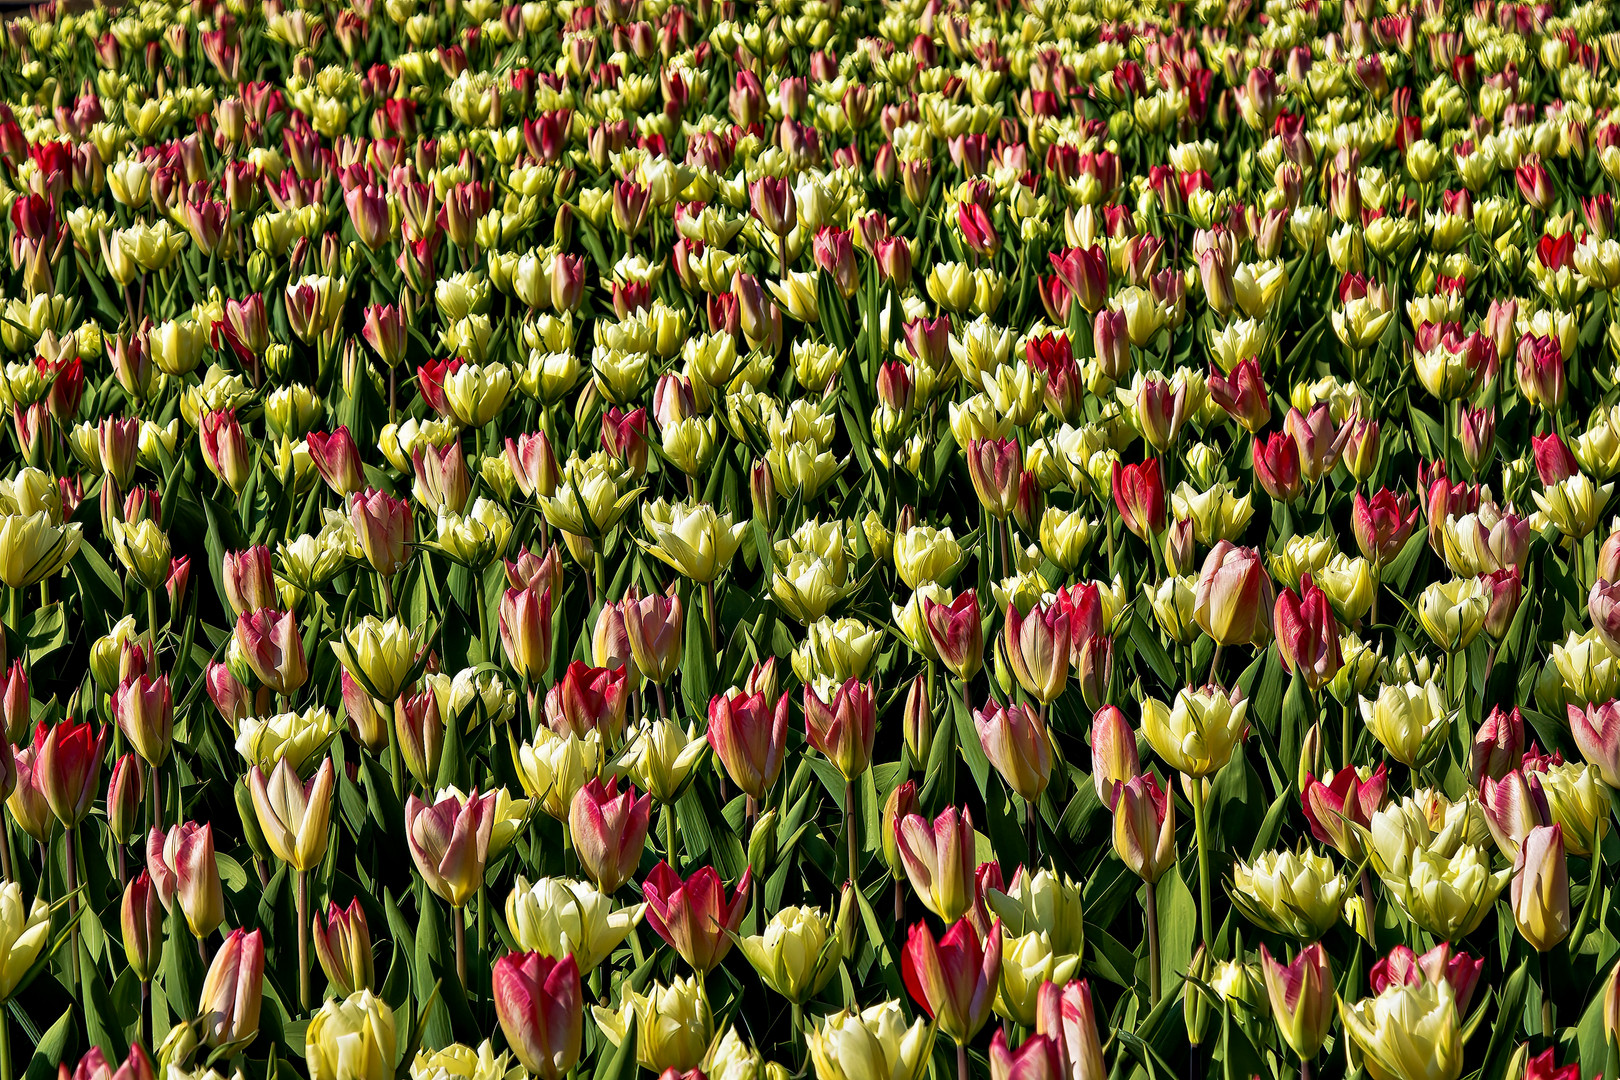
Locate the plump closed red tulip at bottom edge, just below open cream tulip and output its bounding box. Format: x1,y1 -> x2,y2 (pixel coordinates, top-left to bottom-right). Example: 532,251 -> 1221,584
491,952 -> 585,1080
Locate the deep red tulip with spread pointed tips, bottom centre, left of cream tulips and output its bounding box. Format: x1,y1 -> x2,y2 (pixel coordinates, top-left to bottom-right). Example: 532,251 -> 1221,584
901,920 -> 1001,1062
